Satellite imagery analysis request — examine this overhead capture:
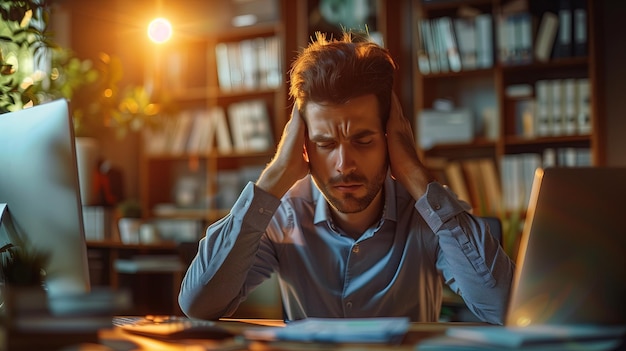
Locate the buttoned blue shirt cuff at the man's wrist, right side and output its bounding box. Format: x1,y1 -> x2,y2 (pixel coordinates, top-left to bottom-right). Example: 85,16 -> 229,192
415,182 -> 471,233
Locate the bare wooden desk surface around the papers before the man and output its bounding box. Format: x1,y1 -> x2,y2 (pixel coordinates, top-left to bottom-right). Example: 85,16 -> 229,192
94,319 -> 478,351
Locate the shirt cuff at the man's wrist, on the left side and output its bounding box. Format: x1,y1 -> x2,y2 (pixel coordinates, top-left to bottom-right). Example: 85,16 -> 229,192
231,182 -> 280,231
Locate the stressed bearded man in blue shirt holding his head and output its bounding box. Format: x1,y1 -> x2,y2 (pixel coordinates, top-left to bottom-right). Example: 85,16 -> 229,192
179,34 -> 513,324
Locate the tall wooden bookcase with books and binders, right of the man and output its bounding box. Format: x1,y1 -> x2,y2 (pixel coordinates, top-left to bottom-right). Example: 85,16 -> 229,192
412,0 -> 605,243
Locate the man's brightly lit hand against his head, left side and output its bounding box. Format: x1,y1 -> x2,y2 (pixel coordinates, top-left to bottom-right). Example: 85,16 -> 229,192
256,103 -> 309,199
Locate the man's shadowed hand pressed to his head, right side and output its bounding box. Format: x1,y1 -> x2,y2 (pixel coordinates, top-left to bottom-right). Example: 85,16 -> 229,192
387,93 -> 433,200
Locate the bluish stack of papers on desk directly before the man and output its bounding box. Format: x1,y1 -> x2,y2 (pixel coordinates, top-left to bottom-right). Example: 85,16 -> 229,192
243,317 -> 409,343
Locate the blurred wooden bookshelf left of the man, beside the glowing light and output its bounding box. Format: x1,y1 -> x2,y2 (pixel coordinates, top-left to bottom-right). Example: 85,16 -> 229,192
140,0 -> 295,224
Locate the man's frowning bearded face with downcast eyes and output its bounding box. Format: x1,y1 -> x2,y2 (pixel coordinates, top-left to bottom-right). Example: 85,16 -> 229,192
304,94 -> 388,213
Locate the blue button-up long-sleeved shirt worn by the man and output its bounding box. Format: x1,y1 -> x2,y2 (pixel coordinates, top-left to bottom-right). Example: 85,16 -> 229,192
179,177 -> 513,324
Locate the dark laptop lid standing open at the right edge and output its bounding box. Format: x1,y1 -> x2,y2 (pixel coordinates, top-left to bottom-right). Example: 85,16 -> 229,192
506,167 -> 626,326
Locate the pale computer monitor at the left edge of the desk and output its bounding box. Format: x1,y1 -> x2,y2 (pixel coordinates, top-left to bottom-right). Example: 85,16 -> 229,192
0,99 -> 90,297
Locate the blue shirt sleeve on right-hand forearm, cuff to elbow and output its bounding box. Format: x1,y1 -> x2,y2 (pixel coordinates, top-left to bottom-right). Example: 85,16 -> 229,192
415,182 -> 514,324
